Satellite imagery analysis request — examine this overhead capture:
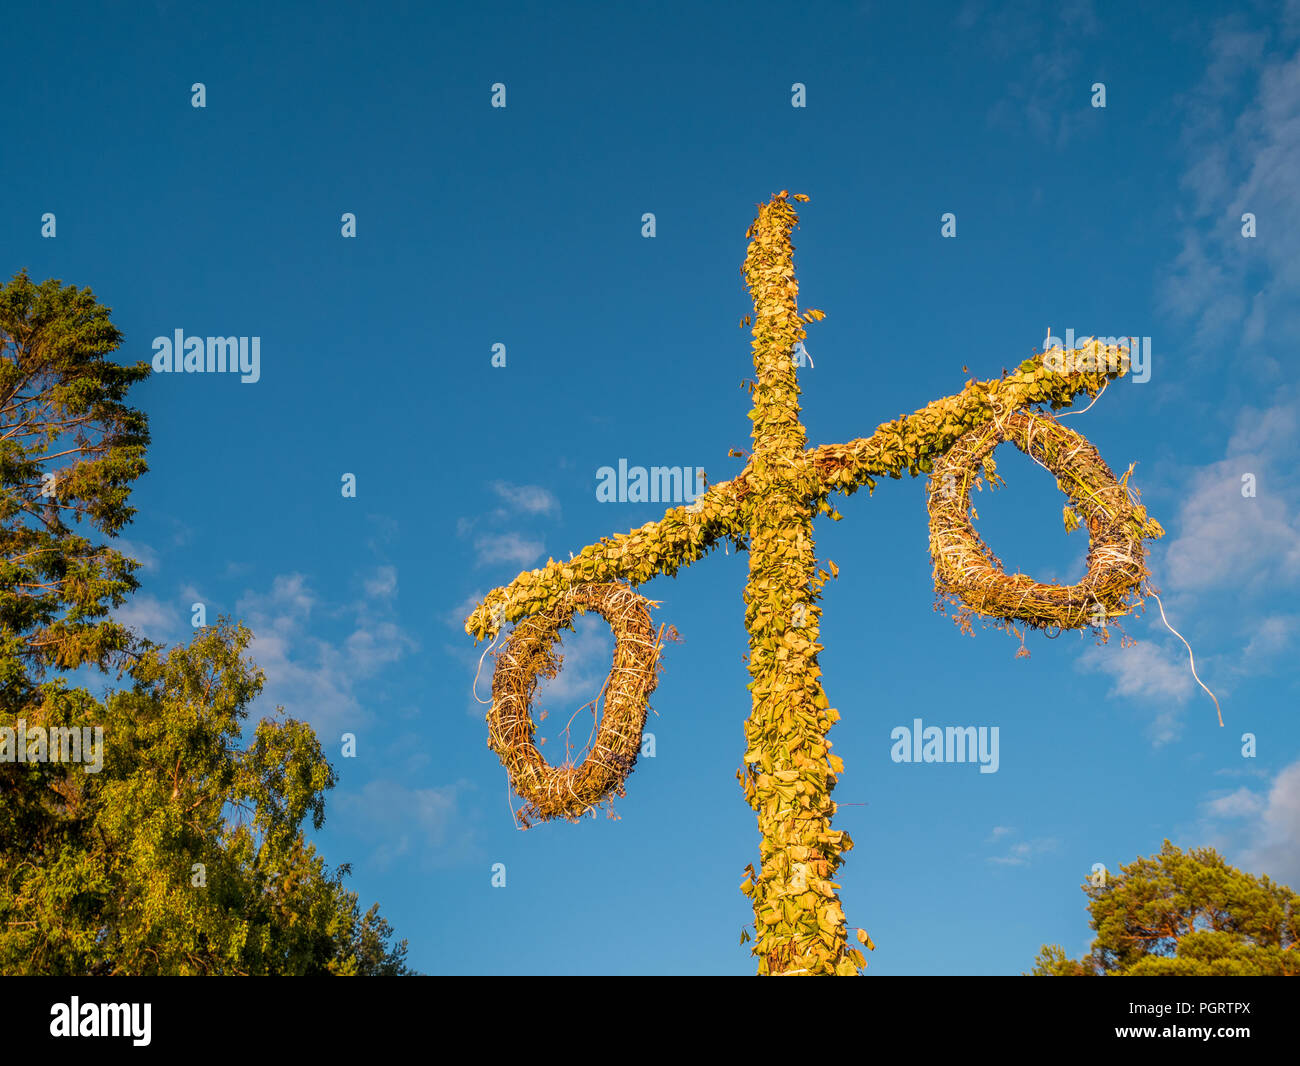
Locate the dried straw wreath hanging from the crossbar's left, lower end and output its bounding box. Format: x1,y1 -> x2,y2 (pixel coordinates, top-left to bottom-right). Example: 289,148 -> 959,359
488,584 -> 660,827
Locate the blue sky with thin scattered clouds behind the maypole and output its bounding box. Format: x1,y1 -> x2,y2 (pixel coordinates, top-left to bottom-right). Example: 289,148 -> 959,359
0,3 -> 1300,975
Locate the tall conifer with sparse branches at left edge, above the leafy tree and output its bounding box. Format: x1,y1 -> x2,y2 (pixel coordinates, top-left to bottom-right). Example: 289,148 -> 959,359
0,272 -> 150,689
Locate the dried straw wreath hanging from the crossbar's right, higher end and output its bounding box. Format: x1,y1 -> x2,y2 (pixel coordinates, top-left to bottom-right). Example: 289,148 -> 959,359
927,411 -> 1164,629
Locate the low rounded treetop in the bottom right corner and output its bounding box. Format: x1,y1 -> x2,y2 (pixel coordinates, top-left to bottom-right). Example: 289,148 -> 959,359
1032,840 -> 1300,976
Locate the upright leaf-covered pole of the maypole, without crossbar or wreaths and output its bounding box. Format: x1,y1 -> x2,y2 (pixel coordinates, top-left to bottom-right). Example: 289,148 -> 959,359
737,192 -> 865,975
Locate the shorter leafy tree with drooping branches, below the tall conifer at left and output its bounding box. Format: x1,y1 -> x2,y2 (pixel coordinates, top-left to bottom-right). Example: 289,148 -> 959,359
0,620 -> 408,975
